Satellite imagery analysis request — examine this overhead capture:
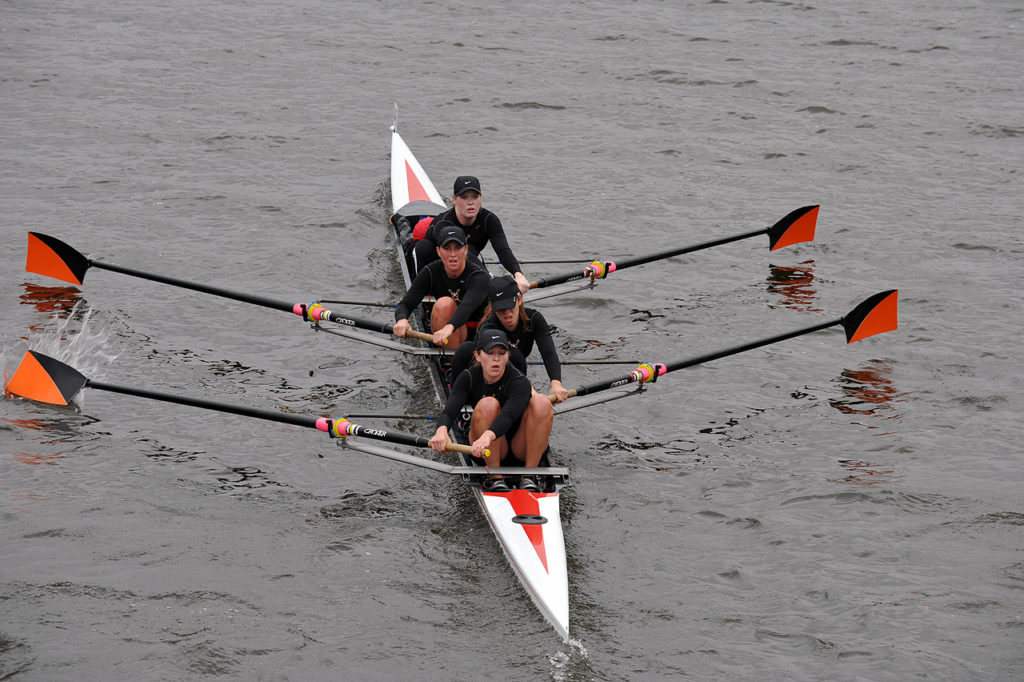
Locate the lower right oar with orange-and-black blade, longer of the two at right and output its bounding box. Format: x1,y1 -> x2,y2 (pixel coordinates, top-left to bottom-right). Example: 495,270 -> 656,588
548,289 -> 898,402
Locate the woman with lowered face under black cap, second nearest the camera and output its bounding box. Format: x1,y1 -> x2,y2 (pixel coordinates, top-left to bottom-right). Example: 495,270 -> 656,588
452,276 -> 569,402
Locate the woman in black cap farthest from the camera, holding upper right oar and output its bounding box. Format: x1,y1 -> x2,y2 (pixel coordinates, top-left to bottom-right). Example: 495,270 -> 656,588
414,175 -> 529,293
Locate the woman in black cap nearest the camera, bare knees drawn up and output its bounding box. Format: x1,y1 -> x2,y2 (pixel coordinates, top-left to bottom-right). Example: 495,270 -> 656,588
430,329 -> 555,492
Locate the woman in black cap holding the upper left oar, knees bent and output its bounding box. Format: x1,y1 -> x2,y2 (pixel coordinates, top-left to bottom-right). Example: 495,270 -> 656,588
394,225 -> 489,347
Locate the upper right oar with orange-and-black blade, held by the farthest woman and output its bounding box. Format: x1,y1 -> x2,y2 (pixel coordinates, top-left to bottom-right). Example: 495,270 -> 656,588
529,201 -> 819,289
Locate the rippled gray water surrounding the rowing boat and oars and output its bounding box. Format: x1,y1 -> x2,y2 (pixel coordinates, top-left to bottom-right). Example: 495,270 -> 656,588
0,0 -> 1024,681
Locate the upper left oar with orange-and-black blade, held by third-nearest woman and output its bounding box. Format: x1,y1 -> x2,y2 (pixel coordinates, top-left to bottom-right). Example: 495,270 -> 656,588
25,232 -> 433,341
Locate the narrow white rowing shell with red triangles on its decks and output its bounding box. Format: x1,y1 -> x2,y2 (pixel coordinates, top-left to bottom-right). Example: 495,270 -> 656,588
391,115 -> 569,639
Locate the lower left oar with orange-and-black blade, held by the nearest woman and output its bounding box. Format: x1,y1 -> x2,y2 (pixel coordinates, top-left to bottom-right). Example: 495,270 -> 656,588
7,350 -> 489,457
